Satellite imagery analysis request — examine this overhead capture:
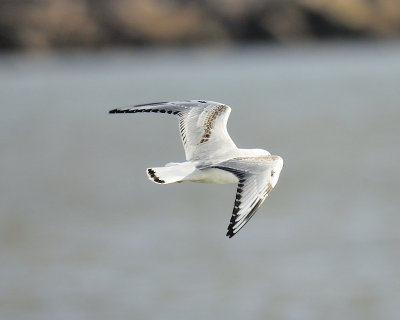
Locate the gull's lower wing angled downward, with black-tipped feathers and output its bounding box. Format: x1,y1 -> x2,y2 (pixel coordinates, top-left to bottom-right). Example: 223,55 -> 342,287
215,156 -> 283,238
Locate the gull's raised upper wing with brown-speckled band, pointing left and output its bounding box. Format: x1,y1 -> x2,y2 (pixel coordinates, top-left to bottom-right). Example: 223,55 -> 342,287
110,100 -> 236,160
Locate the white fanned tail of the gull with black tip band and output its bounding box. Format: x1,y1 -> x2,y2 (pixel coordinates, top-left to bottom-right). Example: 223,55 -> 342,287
146,162 -> 196,184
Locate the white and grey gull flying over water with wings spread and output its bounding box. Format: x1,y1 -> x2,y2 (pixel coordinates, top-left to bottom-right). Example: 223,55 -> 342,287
109,100 -> 283,238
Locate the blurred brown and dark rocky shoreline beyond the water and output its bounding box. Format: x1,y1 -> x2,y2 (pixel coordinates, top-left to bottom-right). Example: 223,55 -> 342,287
0,0 -> 400,51
